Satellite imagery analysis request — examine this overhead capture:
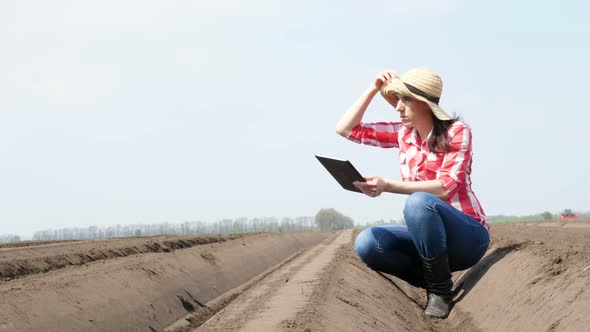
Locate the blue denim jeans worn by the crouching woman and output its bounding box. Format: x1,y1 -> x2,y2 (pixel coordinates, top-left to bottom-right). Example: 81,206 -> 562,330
354,192 -> 490,286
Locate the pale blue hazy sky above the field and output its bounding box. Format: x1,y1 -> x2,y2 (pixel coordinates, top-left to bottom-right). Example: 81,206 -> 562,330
0,0 -> 590,237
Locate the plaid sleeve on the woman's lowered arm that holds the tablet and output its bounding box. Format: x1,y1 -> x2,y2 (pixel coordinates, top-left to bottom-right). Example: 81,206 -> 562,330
436,125 -> 472,198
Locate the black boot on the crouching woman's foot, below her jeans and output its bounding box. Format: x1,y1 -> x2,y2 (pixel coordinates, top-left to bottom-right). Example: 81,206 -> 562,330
420,253 -> 453,318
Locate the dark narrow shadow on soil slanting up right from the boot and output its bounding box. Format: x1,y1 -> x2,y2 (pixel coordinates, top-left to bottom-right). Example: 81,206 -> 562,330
453,243 -> 522,303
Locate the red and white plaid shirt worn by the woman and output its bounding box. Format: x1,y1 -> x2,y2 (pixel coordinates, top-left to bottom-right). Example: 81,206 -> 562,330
347,121 -> 489,229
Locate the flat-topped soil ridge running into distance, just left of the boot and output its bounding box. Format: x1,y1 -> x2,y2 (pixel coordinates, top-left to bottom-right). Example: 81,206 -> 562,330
186,230 -> 477,332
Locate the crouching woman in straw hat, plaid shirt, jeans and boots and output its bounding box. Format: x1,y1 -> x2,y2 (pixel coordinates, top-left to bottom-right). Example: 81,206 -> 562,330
336,68 -> 489,318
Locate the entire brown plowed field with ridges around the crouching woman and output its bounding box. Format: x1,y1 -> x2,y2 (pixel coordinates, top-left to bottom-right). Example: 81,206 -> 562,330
0,221 -> 590,332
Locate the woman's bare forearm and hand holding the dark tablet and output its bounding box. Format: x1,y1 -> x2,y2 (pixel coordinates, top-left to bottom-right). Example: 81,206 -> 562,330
354,176 -> 449,201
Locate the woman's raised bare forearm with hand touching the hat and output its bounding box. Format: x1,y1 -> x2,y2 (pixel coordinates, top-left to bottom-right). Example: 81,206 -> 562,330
336,70 -> 397,137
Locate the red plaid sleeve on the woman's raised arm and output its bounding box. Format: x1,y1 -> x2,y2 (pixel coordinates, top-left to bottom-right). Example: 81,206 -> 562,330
347,122 -> 402,148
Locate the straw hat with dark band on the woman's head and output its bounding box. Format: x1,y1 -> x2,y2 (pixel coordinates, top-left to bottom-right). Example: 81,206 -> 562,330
381,67 -> 451,120
